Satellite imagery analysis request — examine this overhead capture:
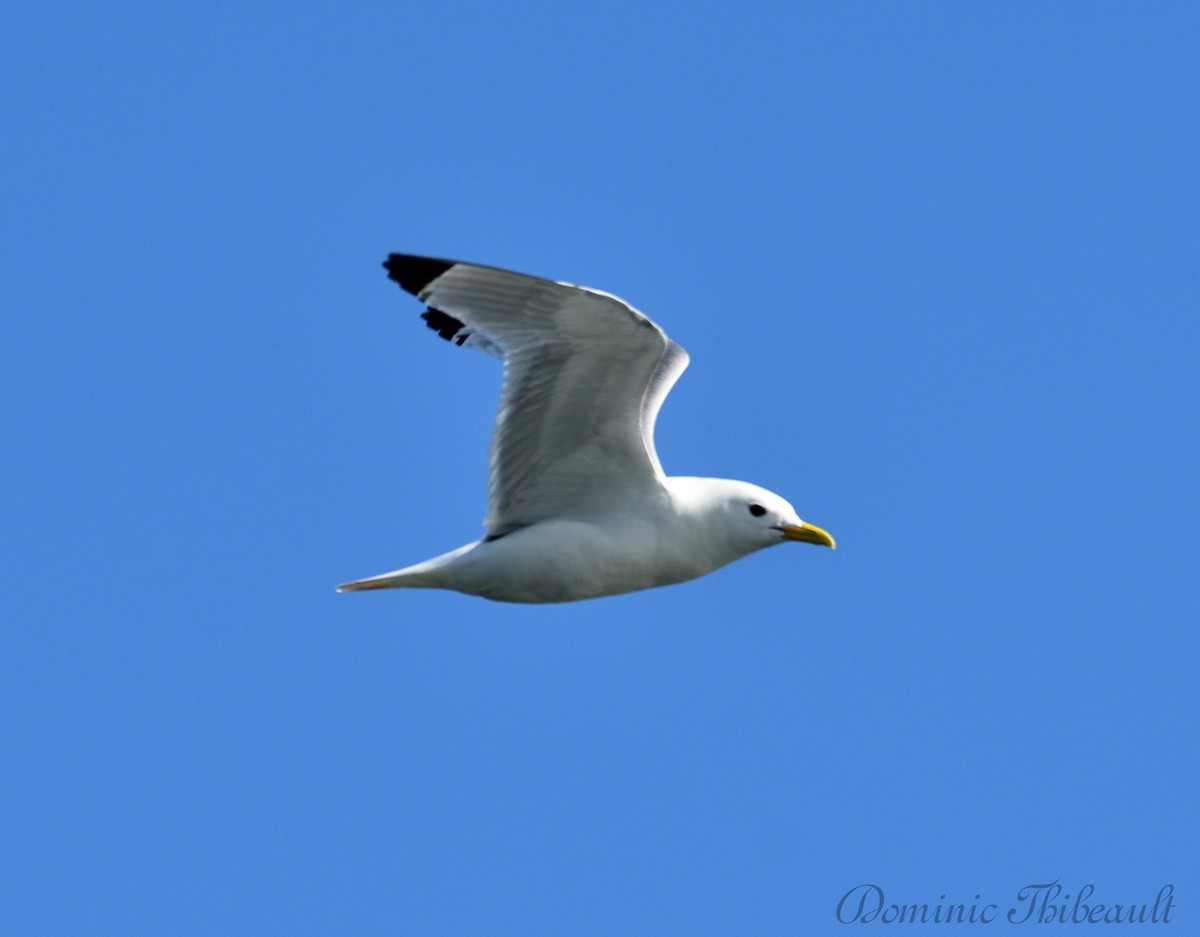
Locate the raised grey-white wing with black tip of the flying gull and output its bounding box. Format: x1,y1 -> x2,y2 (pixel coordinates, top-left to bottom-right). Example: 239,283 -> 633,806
384,254 -> 688,539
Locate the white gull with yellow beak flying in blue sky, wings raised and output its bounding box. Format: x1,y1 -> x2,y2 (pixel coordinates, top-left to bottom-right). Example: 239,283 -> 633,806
337,254 -> 834,602
